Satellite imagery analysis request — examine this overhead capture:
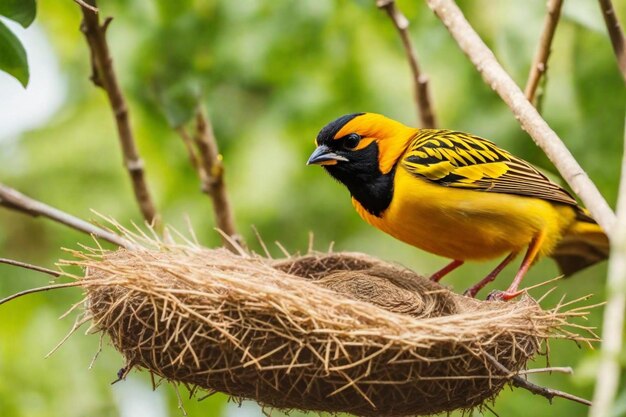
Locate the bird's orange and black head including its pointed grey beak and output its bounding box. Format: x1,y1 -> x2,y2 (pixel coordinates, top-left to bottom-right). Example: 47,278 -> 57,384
307,113 -> 410,216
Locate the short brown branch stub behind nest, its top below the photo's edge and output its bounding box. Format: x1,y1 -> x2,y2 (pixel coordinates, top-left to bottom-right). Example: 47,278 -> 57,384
194,107 -> 245,253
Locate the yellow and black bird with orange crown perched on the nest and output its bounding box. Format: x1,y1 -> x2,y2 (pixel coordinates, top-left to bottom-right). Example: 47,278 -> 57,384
307,113 -> 609,301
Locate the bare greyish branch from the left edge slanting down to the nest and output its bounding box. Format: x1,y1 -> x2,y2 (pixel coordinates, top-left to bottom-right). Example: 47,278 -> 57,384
0,184 -> 133,249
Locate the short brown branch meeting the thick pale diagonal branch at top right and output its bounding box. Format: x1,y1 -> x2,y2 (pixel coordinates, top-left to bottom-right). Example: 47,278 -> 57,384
524,0 -> 563,104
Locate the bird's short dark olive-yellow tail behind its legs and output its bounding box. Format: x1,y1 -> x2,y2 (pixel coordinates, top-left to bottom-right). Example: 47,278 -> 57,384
551,210 -> 609,276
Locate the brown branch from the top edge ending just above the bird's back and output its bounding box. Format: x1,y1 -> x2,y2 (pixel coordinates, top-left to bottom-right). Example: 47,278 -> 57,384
376,0 -> 437,129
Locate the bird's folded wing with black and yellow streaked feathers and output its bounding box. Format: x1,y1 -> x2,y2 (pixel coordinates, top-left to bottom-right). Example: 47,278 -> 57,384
402,129 -> 577,205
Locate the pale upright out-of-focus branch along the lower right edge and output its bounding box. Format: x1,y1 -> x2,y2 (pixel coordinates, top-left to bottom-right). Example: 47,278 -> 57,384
589,114 -> 626,417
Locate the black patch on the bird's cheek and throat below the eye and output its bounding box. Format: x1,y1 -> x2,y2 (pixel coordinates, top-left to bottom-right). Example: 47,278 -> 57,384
324,142 -> 396,217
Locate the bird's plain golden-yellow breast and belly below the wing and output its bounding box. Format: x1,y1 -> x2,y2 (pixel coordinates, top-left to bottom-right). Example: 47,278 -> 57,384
352,166 -> 575,260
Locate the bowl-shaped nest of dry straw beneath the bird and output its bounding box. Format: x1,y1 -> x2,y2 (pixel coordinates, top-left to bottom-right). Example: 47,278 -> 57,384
72,246 -> 584,416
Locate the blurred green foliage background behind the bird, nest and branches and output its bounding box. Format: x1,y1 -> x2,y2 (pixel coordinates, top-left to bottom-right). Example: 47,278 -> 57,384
0,0 -> 626,417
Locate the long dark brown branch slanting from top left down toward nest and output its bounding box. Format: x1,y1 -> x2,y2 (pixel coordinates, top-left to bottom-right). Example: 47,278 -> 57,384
81,0 -> 159,225
